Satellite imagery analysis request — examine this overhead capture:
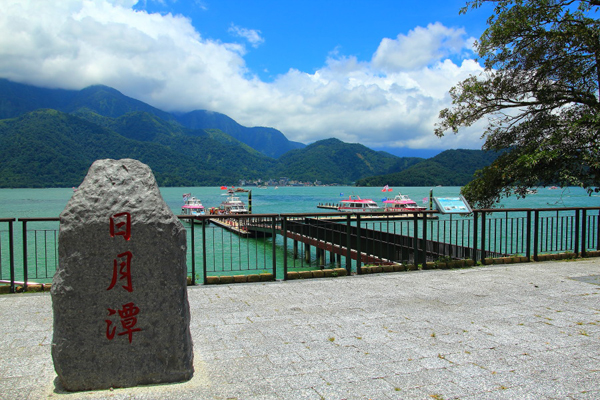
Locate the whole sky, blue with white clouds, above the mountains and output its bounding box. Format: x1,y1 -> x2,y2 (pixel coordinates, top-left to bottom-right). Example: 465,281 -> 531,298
0,0 -> 491,156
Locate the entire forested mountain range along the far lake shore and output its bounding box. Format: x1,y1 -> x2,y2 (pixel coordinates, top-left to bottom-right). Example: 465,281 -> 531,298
0,79 -> 494,187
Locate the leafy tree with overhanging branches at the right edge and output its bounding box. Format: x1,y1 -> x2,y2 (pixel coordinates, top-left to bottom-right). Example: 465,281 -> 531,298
435,0 -> 600,208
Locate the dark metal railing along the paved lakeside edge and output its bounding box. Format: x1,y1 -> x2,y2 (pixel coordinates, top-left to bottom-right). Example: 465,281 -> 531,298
0,207 -> 600,293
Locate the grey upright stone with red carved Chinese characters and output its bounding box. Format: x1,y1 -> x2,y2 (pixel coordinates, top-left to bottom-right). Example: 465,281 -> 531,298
51,159 -> 194,391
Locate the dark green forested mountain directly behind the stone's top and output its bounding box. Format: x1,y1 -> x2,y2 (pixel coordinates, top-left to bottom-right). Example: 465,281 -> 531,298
0,109 -> 277,187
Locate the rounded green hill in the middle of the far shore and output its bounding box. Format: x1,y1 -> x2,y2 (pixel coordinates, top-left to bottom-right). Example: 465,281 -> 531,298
278,139 -> 421,183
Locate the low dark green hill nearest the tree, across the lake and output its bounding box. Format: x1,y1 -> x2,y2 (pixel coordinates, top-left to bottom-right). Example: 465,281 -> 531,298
357,150 -> 498,186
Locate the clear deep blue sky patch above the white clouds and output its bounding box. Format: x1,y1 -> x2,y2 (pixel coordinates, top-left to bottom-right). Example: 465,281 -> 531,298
135,0 -> 486,81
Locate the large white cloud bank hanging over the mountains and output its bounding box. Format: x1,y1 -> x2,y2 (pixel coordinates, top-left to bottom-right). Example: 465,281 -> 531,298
0,0 -> 482,153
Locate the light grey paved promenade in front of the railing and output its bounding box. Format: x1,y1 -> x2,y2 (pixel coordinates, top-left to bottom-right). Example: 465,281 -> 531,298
0,258 -> 600,400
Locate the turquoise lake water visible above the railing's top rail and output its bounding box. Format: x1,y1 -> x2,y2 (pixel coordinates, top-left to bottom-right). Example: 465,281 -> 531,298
0,186 -> 600,218
